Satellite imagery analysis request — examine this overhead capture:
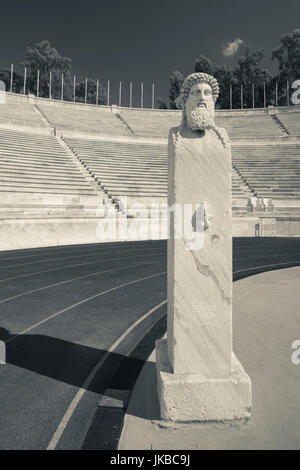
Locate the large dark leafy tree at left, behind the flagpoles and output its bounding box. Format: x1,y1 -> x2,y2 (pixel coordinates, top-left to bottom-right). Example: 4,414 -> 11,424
22,41 -> 72,100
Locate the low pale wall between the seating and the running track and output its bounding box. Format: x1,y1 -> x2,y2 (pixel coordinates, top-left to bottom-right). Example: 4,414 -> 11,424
0,217 -> 300,251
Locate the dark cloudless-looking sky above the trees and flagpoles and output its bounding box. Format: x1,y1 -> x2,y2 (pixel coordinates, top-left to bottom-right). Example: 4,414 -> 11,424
0,0 -> 300,106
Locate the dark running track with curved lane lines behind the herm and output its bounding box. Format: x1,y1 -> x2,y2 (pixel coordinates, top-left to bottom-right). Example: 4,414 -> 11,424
0,238 -> 300,449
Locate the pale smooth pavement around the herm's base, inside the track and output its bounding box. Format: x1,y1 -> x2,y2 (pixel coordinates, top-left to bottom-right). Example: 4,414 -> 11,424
119,267 -> 300,450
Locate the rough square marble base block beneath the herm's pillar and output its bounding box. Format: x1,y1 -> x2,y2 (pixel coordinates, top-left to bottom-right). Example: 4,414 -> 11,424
156,339 -> 251,421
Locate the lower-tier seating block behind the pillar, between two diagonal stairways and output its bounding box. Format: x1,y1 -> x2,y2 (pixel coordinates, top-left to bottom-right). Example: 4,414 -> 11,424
65,137 -> 252,209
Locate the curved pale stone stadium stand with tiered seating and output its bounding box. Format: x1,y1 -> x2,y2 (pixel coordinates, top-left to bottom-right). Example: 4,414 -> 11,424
0,93 -> 300,249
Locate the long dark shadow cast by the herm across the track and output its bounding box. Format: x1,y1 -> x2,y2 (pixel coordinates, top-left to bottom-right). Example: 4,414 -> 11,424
0,316 -> 166,408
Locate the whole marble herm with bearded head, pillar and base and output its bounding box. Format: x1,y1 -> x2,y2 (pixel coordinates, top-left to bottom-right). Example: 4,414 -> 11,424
156,73 -> 251,421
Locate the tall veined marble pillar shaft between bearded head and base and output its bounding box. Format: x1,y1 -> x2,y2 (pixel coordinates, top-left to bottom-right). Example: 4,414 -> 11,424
168,128 -> 232,378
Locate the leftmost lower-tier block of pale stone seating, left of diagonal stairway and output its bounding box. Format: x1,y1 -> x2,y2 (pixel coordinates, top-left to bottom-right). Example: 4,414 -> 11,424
0,129 -> 110,219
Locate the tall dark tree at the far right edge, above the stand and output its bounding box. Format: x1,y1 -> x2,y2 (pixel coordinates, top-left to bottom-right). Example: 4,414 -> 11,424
272,29 -> 300,105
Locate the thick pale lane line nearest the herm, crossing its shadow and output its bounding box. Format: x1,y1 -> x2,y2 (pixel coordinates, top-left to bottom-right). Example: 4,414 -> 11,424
47,300 -> 167,450
